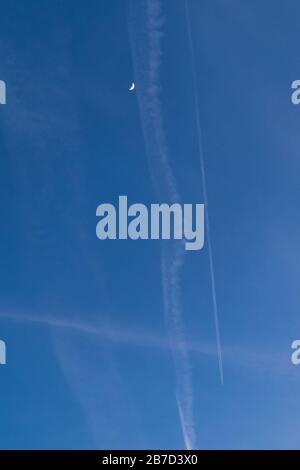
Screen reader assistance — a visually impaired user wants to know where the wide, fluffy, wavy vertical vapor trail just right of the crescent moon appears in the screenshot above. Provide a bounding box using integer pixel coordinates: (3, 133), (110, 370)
(130, 0), (196, 449)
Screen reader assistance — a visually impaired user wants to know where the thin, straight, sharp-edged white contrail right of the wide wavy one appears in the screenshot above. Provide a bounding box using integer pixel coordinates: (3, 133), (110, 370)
(185, 0), (224, 385)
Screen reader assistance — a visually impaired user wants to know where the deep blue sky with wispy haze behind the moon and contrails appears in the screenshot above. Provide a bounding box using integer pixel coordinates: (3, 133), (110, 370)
(0, 0), (300, 449)
